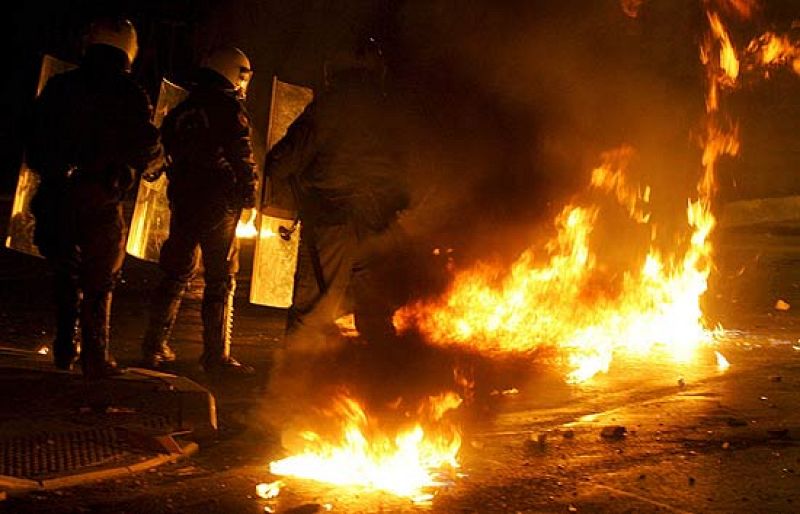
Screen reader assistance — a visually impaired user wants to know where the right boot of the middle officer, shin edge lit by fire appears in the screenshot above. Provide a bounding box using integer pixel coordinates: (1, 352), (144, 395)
(200, 279), (255, 376)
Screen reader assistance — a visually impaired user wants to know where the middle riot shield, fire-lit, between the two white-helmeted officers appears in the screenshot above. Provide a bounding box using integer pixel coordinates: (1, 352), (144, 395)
(126, 79), (187, 262)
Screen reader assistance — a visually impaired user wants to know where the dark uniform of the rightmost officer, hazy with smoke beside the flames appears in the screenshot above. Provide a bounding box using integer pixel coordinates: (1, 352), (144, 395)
(265, 69), (408, 348)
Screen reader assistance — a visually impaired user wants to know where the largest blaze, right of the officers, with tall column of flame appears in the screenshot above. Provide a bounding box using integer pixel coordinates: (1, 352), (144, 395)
(395, 10), (755, 382)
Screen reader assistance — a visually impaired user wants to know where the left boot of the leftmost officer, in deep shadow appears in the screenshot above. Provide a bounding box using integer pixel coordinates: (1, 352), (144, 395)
(53, 273), (80, 371)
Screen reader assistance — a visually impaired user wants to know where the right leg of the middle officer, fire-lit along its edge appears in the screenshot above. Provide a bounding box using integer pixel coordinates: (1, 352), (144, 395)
(200, 211), (253, 375)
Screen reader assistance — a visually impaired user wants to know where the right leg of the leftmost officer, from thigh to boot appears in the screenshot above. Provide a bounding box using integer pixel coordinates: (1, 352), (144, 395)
(78, 198), (126, 379)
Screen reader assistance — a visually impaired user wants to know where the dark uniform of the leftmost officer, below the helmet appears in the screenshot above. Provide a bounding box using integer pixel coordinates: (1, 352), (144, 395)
(26, 44), (163, 377)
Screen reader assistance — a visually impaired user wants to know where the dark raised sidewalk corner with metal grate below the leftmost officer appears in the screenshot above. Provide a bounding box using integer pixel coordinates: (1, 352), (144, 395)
(0, 348), (217, 496)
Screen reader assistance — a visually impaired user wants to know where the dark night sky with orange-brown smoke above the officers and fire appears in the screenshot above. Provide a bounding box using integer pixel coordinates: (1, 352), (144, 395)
(0, 0), (800, 260)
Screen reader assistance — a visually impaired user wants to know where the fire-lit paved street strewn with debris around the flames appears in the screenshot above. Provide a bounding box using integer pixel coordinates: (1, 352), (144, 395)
(0, 200), (800, 513)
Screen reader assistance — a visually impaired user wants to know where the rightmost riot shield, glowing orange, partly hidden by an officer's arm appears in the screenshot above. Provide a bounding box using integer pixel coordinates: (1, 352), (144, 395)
(250, 77), (314, 308)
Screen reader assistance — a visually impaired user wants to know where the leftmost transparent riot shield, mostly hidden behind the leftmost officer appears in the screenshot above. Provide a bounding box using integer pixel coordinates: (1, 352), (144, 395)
(6, 55), (75, 257)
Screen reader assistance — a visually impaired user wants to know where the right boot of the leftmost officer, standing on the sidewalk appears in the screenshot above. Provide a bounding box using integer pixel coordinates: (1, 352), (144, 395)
(80, 291), (122, 380)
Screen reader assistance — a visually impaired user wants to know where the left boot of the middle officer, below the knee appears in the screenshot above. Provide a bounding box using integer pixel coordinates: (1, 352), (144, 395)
(142, 278), (186, 368)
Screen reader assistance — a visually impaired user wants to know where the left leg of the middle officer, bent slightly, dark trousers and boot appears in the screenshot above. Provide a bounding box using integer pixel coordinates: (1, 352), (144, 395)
(142, 213), (198, 367)
